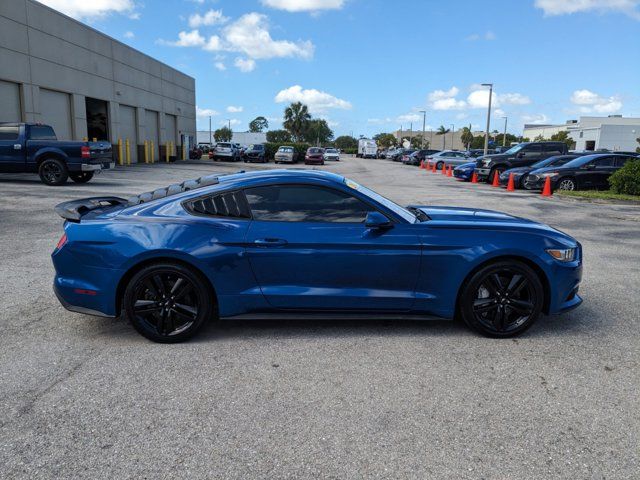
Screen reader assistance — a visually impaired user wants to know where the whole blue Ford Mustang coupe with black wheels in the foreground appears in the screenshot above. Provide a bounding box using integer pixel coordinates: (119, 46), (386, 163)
(52, 170), (582, 342)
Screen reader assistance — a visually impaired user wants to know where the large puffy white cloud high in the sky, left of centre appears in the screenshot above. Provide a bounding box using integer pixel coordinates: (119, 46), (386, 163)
(223, 12), (315, 59)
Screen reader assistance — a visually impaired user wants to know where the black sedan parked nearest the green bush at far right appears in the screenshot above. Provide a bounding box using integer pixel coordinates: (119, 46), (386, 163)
(524, 153), (638, 191)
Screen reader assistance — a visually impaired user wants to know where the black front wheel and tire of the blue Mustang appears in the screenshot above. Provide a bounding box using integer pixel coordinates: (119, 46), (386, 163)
(458, 260), (544, 338)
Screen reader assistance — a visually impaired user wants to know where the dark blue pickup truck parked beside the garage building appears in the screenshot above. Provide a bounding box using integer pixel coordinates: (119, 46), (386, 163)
(0, 123), (114, 185)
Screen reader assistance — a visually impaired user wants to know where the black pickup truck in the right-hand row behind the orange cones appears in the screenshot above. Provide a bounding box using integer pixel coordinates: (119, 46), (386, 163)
(476, 142), (569, 182)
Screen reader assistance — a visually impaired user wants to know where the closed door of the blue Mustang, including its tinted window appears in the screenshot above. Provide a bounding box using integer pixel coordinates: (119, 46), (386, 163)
(245, 184), (421, 311)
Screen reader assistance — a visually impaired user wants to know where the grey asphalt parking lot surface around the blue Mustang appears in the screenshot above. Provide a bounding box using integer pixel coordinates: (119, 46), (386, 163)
(0, 158), (640, 479)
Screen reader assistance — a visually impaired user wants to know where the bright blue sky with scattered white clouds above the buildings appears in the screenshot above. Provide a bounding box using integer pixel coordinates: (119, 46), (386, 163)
(43, 0), (640, 136)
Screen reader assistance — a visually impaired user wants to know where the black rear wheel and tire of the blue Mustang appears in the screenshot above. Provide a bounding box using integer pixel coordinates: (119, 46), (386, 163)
(123, 262), (214, 343)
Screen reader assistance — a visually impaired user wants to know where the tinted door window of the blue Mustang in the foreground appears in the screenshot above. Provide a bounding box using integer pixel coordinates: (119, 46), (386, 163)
(244, 185), (373, 223)
